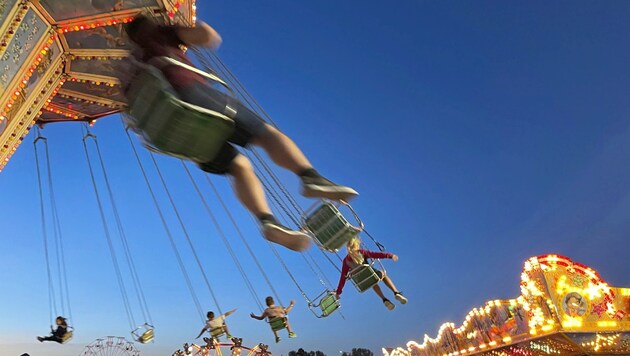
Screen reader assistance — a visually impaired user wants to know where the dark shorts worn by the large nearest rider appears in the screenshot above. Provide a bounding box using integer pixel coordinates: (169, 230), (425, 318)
(177, 84), (265, 174)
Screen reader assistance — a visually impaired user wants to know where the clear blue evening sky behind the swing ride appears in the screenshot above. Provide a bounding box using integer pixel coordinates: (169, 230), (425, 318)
(0, 0), (630, 356)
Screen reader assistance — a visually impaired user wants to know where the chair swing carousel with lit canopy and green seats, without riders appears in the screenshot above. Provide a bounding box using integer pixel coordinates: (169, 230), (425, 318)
(0, 0), (404, 343)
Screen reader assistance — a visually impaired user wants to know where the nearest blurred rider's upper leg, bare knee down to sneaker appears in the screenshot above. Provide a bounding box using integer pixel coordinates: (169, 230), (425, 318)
(251, 124), (359, 200)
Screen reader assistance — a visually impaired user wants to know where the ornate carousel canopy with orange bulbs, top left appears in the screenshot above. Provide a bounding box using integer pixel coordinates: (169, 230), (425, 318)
(0, 0), (195, 171)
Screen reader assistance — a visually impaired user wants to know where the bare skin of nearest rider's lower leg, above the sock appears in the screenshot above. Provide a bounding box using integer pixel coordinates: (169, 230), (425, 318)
(230, 154), (271, 216)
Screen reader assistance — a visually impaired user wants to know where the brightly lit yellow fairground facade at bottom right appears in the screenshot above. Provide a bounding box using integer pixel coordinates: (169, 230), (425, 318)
(383, 255), (630, 356)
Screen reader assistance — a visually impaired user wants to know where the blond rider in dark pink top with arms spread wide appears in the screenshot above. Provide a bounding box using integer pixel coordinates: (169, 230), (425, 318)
(336, 237), (407, 310)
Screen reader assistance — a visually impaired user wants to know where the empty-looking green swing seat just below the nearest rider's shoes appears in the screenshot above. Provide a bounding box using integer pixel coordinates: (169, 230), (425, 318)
(304, 202), (361, 252)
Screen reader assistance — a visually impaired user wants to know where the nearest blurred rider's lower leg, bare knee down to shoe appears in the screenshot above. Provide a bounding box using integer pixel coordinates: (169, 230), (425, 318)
(229, 154), (310, 251)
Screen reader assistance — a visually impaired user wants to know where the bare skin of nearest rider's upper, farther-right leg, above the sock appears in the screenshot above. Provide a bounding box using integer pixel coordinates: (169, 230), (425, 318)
(252, 124), (313, 174)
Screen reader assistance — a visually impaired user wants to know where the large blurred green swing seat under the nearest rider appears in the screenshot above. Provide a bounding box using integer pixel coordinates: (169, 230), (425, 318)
(127, 65), (234, 163)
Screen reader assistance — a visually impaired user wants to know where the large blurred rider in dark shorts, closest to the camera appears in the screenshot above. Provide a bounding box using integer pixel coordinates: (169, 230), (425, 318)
(125, 15), (358, 251)
